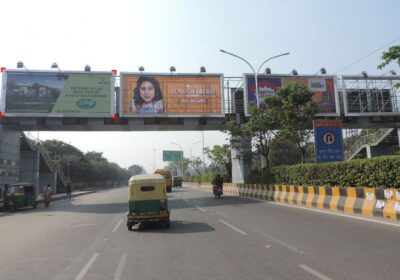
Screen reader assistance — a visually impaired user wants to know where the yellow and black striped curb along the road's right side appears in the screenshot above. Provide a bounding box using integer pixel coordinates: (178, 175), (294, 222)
(185, 183), (400, 220)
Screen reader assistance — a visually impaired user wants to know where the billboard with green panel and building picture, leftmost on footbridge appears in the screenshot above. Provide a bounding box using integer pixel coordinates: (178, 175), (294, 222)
(2, 71), (114, 117)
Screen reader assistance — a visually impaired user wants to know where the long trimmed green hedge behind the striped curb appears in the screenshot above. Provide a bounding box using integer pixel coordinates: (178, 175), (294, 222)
(272, 156), (400, 188)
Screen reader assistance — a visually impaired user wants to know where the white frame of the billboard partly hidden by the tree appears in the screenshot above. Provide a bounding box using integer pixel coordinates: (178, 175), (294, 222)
(243, 73), (340, 117)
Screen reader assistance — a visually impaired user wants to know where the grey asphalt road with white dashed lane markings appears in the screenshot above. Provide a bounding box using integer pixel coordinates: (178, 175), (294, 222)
(0, 185), (400, 280)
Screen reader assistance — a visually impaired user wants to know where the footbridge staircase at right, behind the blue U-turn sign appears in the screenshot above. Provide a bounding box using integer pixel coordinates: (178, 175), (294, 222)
(344, 128), (395, 161)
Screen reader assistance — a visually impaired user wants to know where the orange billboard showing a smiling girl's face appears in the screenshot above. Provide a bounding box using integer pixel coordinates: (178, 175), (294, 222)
(120, 73), (224, 117)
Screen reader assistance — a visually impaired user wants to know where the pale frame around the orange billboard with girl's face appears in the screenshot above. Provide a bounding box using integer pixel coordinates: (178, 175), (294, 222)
(117, 72), (225, 118)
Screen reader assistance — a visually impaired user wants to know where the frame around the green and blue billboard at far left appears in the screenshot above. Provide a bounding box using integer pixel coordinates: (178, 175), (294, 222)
(0, 69), (116, 118)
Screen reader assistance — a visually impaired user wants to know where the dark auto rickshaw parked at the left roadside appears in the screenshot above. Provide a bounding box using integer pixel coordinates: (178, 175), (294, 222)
(3, 182), (36, 211)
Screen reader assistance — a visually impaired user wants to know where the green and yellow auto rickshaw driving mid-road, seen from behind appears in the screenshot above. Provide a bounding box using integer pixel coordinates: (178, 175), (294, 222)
(127, 174), (170, 230)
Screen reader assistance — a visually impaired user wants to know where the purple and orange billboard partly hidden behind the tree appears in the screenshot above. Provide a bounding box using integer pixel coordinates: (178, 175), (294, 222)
(244, 74), (340, 116)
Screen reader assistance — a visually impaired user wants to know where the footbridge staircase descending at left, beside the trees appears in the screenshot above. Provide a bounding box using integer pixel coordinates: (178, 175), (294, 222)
(21, 132), (68, 186)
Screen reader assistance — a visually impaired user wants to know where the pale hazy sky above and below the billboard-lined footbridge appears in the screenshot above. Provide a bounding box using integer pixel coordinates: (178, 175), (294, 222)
(0, 0), (400, 171)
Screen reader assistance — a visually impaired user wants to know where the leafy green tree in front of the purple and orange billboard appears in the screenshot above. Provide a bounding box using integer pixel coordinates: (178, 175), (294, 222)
(265, 83), (318, 163)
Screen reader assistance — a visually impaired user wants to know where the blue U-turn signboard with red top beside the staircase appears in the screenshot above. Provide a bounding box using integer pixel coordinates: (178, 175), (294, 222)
(314, 120), (344, 163)
